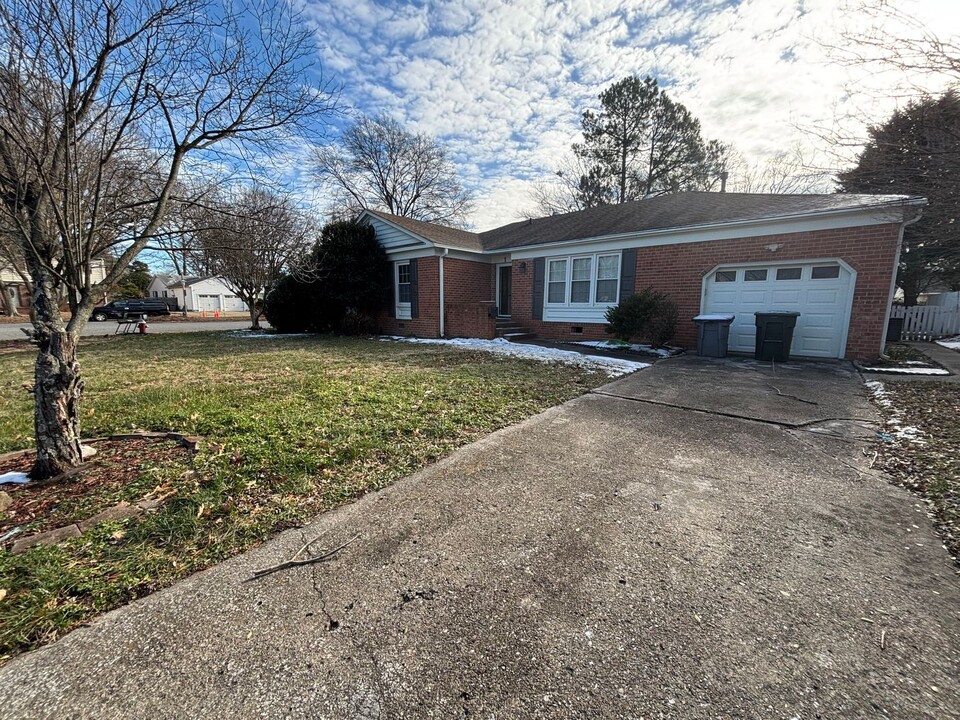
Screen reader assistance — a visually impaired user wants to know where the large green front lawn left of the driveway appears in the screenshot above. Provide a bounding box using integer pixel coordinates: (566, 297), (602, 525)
(0, 333), (606, 662)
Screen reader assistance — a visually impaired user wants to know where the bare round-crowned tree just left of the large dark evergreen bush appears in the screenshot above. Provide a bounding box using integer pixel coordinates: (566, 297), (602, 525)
(191, 187), (318, 330)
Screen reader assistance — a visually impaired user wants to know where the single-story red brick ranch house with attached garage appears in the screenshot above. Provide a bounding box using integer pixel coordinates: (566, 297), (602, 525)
(361, 192), (926, 359)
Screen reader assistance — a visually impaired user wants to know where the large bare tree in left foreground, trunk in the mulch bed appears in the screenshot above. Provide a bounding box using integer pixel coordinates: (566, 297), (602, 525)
(0, 0), (333, 479)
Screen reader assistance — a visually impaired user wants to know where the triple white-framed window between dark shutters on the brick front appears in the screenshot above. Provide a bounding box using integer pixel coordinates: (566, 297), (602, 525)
(547, 253), (620, 307)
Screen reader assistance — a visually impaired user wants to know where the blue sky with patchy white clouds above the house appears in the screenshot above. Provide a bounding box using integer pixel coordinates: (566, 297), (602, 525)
(297, 0), (960, 230)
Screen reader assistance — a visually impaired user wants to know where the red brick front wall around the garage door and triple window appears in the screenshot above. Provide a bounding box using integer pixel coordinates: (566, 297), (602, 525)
(513, 224), (900, 358)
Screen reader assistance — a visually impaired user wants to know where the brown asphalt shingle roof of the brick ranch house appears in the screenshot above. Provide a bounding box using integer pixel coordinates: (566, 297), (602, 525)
(371, 192), (920, 252)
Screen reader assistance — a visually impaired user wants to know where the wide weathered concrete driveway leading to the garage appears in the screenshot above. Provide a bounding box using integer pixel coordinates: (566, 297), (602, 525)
(0, 357), (960, 719)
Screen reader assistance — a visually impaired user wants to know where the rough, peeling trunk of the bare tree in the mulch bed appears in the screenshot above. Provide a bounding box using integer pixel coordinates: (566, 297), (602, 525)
(30, 281), (83, 480)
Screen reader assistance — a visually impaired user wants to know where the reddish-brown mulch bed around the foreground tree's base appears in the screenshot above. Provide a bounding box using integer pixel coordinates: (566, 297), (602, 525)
(0, 438), (193, 536)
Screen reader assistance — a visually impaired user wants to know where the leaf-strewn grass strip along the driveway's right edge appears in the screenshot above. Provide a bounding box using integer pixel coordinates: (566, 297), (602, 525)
(880, 380), (960, 561)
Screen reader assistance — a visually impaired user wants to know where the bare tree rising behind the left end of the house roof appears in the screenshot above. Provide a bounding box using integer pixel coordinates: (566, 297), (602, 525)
(315, 116), (472, 226)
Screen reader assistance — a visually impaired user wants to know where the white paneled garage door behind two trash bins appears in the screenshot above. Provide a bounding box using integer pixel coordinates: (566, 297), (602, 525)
(702, 262), (854, 358)
